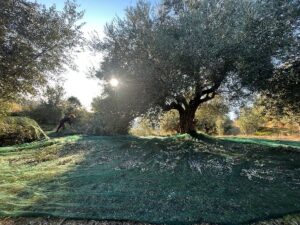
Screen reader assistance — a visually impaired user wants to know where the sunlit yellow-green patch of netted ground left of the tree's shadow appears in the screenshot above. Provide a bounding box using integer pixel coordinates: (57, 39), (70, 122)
(0, 136), (84, 215)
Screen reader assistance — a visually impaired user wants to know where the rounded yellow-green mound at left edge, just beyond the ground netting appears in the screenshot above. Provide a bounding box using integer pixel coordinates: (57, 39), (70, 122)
(0, 117), (48, 146)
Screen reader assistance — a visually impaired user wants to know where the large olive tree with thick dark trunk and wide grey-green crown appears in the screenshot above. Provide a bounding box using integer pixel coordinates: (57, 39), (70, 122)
(93, 0), (300, 133)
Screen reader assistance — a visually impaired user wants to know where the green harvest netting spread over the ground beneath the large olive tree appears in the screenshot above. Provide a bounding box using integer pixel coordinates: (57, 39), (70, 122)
(0, 136), (300, 224)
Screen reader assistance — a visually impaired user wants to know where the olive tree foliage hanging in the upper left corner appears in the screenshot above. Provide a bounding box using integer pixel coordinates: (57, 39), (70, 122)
(0, 0), (83, 101)
